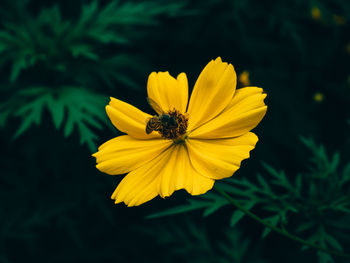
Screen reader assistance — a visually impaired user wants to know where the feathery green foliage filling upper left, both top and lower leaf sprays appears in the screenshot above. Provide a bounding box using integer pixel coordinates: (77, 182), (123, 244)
(0, 0), (184, 151)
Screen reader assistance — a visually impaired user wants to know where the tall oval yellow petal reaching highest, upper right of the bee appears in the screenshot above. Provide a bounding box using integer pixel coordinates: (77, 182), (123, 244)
(187, 57), (237, 130)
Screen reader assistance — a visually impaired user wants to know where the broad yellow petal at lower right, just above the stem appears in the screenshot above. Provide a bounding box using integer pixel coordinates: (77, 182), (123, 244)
(186, 132), (258, 180)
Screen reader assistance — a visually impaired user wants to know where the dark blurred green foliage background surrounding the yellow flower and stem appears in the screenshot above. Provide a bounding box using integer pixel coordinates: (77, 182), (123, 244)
(0, 0), (350, 263)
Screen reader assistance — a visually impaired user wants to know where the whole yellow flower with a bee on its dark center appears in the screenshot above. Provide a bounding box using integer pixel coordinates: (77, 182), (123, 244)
(93, 57), (267, 206)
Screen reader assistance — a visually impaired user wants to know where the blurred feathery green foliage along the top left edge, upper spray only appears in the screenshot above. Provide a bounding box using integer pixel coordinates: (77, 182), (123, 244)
(0, 1), (184, 84)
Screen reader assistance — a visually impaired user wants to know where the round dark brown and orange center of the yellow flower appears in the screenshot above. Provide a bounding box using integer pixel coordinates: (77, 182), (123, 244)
(155, 109), (188, 143)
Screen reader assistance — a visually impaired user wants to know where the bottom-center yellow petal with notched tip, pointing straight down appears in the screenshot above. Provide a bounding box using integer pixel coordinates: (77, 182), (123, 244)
(159, 144), (214, 198)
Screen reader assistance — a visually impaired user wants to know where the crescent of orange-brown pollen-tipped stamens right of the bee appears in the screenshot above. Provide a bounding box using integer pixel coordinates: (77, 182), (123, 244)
(159, 109), (188, 140)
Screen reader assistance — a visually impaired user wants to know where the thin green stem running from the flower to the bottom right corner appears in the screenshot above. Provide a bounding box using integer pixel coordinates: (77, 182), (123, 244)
(214, 185), (350, 259)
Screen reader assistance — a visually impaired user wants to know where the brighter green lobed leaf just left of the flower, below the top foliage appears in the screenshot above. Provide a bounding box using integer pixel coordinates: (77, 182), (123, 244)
(9, 86), (108, 151)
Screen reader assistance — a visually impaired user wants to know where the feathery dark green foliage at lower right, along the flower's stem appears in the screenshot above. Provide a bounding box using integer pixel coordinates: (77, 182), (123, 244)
(149, 138), (350, 263)
